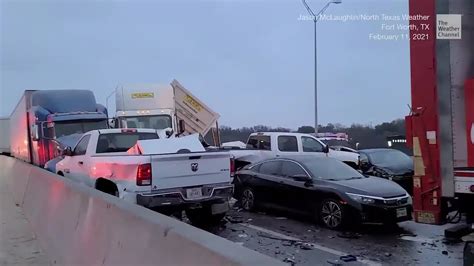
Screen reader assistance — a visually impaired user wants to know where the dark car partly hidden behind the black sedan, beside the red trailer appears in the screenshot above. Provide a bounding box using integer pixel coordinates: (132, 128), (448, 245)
(359, 149), (414, 195)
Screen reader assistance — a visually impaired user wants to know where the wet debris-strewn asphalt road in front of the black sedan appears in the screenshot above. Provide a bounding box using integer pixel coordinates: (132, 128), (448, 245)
(194, 209), (464, 265)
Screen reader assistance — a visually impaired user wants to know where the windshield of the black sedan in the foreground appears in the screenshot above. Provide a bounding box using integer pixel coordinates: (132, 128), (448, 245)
(302, 158), (364, 181)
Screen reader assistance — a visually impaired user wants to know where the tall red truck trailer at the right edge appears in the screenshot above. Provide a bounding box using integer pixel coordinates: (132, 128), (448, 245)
(406, 0), (474, 224)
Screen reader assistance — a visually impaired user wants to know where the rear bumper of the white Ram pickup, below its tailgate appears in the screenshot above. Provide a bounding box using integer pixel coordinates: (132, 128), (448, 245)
(137, 183), (234, 209)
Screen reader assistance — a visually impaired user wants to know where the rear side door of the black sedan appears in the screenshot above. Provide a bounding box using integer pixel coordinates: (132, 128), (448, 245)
(252, 160), (281, 204)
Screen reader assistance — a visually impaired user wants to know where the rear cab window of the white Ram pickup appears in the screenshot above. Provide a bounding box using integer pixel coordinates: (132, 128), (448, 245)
(96, 132), (159, 153)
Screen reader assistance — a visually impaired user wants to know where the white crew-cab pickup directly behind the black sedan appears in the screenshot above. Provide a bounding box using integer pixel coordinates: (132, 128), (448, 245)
(227, 132), (360, 169)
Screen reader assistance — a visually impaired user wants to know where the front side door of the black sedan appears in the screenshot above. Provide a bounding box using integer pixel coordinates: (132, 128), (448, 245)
(278, 160), (312, 212)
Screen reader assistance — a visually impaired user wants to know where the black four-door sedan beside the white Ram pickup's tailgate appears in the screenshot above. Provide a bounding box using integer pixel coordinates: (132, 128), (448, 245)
(234, 156), (412, 229)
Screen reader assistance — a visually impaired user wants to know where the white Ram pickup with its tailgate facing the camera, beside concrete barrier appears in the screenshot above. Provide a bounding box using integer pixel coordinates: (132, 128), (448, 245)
(56, 129), (233, 224)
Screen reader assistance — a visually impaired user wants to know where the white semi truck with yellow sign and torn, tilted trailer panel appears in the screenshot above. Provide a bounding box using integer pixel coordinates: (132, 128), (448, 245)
(113, 80), (219, 140)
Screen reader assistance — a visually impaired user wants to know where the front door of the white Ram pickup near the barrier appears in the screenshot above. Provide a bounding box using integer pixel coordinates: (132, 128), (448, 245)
(64, 135), (91, 183)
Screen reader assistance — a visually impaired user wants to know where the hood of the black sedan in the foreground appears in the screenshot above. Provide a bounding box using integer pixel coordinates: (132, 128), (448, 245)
(330, 176), (407, 198)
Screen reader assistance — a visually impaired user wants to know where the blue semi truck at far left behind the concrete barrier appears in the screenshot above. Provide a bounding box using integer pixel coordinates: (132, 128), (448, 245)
(10, 90), (108, 167)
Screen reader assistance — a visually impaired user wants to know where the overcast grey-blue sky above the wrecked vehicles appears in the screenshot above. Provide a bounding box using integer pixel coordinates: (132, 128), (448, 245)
(0, 0), (410, 128)
